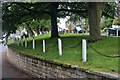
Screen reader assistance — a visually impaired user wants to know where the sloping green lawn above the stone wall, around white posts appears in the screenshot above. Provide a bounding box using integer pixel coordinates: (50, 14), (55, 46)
(9, 34), (120, 73)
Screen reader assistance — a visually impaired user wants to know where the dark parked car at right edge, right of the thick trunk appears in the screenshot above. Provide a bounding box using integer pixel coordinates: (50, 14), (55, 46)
(108, 25), (120, 36)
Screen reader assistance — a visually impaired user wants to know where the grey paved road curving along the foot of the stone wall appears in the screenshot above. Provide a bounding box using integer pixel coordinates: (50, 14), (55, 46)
(0, 44), (29, 79)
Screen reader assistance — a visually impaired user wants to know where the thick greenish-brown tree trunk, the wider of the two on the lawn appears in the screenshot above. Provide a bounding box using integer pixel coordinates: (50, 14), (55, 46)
(88, 2), (104, 42)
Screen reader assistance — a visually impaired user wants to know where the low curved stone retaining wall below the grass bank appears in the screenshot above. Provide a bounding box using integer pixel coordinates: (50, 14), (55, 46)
(7, 49), (116, 80)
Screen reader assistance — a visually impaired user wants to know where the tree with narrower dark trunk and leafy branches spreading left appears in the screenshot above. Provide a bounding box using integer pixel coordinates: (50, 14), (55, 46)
(1, 3), (87, 37)
